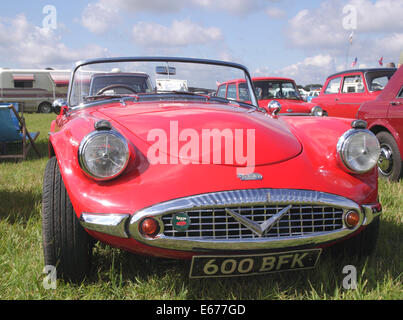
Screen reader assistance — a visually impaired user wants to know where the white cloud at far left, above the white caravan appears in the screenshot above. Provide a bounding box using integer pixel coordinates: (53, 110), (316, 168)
(0, 15), (106, 68)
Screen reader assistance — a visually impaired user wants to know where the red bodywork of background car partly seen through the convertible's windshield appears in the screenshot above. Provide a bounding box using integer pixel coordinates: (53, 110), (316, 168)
(217, 77), (317, 114)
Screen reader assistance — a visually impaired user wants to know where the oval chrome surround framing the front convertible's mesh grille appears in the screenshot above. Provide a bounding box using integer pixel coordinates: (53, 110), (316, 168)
(129, 189), (369, 251)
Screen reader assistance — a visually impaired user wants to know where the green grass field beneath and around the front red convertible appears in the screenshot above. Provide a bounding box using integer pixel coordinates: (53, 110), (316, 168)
(0, 114), (403, 300)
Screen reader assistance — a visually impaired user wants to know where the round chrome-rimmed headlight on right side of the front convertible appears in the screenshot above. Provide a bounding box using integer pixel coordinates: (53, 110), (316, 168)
(337, 129), (380, 173)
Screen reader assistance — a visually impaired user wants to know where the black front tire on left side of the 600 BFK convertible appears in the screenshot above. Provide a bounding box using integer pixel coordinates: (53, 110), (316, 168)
(42, 157), (92, 282)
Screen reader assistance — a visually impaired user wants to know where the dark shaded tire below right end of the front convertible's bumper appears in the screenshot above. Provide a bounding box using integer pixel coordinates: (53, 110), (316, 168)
(331, 217), (380, 258)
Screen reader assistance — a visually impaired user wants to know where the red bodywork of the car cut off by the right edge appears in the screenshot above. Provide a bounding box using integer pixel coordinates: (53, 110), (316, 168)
(357, 67), (403, 160)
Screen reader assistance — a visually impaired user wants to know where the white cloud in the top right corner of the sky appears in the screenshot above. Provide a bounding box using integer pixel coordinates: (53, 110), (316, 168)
(286, 0), (403, 50)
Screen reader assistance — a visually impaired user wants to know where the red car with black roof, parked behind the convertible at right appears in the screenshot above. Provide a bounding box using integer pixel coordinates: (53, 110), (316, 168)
(312, 68), (396, 118)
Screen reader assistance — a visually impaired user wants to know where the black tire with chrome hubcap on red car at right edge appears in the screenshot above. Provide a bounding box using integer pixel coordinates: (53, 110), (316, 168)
(376, 131), (402, 181)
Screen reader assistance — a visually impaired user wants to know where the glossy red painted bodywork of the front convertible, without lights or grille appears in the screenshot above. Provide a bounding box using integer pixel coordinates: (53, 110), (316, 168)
(49, 102), (378, 259)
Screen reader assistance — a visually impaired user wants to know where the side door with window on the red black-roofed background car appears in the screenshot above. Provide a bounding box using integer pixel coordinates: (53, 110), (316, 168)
(335, 73), (368, 118)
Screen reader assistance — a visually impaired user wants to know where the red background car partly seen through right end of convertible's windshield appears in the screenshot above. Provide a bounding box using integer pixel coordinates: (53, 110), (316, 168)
(216, 77), (326, 116)
